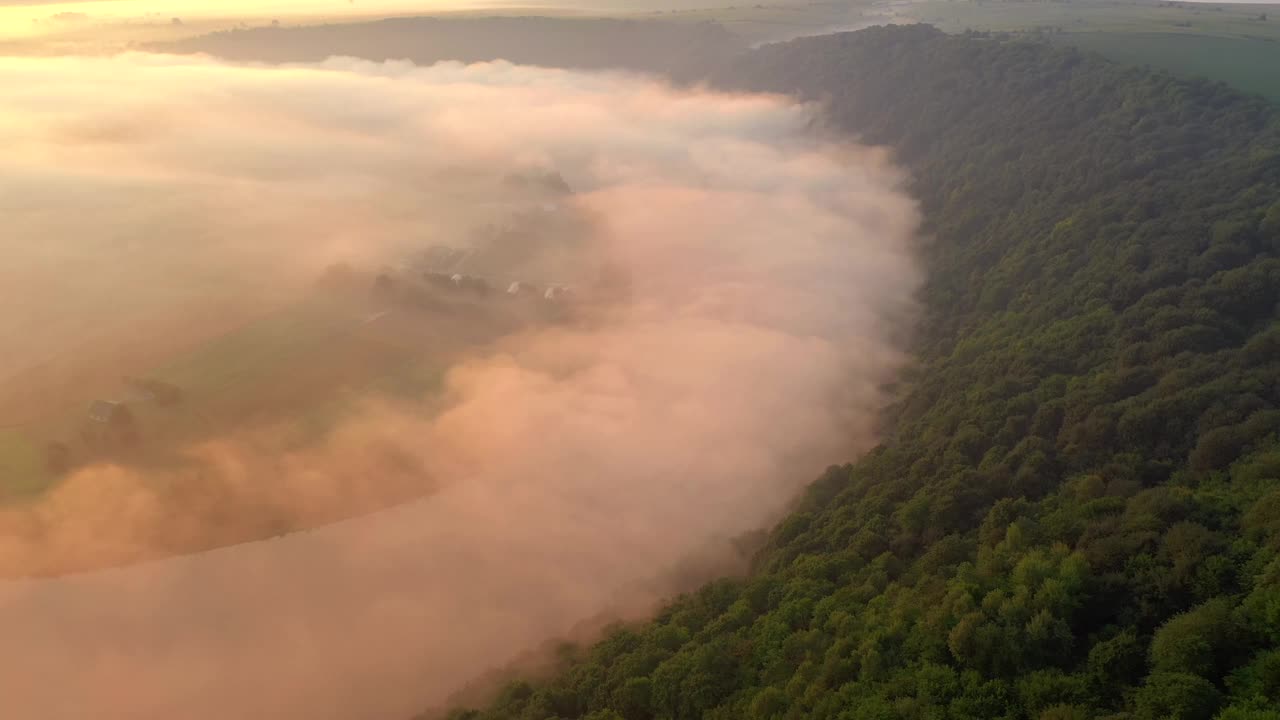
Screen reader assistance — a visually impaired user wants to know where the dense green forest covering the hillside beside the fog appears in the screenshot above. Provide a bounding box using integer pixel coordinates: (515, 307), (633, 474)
(437, 27), (1280, 720)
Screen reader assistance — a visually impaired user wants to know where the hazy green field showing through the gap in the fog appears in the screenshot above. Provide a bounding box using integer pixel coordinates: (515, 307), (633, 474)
(0, 280), (522, 500)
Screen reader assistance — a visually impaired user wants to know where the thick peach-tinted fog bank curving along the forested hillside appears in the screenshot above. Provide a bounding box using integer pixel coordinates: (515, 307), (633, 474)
(0, 55), (922, 720)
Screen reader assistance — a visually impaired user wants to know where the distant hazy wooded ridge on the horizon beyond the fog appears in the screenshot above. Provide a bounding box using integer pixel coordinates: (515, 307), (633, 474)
(151, 17), (745, 78)
